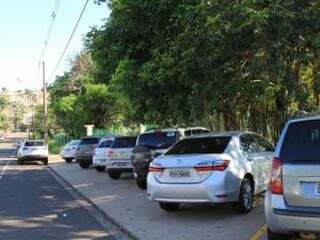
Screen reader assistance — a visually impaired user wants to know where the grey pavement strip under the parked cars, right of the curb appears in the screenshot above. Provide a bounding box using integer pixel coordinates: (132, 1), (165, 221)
(49, 156), (264, 240)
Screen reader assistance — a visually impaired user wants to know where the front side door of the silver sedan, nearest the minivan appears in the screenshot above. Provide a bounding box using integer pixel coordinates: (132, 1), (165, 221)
(254, 135), (274, 191)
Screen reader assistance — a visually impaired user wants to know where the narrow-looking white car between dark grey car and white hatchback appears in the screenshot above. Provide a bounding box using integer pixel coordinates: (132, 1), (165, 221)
(93, 137), (114, 172)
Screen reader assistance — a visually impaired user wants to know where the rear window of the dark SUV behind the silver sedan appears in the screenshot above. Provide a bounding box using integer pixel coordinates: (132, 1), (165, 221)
(138, 131), (179, 149)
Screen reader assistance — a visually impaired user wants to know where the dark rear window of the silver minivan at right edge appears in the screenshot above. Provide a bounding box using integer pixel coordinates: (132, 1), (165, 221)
(280, 120), (320, 162)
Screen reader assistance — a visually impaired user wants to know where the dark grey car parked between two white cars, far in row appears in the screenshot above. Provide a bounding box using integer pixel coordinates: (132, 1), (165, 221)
(75, 136), (100, 168)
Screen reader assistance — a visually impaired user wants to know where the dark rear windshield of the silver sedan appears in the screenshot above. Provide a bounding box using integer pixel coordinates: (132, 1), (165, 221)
(165, 137), (231, 155)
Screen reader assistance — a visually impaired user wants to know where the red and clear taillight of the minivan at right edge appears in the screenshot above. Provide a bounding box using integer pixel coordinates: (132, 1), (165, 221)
(269, 158), (283, 195)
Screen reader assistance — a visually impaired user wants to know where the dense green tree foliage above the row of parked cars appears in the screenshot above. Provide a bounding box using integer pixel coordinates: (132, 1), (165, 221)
(51, 0), (320, 141)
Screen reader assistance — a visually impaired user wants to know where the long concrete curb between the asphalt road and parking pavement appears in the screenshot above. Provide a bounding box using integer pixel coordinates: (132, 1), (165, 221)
(48, 165), (139, 240)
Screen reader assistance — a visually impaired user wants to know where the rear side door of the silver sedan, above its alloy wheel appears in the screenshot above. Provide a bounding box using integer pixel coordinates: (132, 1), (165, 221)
(240, 133), (264, 192)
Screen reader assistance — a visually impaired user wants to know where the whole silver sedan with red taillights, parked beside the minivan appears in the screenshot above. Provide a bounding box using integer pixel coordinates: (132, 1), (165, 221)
(147, 132), (274, 213)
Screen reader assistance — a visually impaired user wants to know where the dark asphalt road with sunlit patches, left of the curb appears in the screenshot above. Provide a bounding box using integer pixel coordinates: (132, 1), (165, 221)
(0, 140), (114, 240)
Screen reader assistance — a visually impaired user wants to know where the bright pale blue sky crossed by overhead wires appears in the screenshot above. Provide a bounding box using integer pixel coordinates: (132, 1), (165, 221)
(0, 0), (110, 90)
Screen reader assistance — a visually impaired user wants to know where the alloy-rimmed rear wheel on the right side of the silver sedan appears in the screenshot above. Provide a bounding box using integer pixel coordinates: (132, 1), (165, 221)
(235, 178), (254, 214)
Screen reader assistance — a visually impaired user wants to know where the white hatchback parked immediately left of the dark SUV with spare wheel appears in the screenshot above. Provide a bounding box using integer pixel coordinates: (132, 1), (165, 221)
(106, 137), (137, 179)
